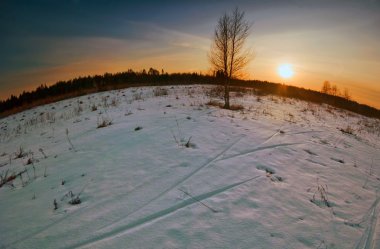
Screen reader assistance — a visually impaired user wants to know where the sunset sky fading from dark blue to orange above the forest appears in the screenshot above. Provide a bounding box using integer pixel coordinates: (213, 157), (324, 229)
(0, 0), (380, 108)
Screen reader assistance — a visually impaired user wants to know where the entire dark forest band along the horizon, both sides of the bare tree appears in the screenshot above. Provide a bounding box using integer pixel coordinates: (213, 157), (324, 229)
(0, 68), (380, 119)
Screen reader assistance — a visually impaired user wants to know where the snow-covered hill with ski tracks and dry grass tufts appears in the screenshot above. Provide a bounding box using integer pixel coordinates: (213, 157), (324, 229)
(0, 86), (380, 249)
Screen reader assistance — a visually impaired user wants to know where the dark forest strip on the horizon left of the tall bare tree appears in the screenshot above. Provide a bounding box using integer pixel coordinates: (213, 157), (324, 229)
(0, 68), (215, 117)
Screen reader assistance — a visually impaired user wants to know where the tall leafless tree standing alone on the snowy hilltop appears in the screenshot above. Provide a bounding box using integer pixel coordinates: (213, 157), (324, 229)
(209, 8), (252, 109)
